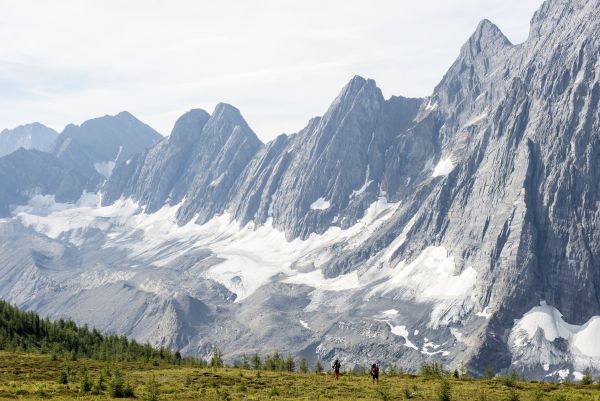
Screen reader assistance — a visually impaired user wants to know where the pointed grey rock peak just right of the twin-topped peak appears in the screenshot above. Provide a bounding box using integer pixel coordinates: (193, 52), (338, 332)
(230, 77), (422, 238)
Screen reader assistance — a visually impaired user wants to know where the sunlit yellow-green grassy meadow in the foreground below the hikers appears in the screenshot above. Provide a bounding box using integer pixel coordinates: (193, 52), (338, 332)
(0, 351), (600, 401)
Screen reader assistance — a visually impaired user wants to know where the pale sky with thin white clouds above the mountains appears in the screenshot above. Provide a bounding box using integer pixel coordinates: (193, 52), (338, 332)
(0, 0), (542, 141)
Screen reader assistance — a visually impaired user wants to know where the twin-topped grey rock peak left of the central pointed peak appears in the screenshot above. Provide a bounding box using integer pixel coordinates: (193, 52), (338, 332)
(103, 103), (262, 223)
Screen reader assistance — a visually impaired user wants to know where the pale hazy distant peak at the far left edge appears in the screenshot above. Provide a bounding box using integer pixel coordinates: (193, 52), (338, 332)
(0, 123), (58, 157)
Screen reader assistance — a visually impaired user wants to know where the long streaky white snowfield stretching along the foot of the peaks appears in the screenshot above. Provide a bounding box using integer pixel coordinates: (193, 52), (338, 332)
(15, 194), (477, 327)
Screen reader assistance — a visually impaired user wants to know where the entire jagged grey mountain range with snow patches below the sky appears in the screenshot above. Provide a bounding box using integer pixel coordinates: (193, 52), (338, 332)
(0, 0), (600, 380)
